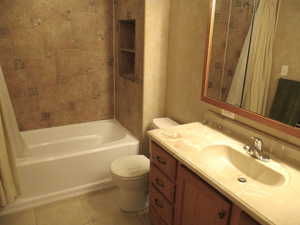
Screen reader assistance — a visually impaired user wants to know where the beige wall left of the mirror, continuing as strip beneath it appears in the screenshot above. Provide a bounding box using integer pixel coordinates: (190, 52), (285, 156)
(166, 0), (299, 145)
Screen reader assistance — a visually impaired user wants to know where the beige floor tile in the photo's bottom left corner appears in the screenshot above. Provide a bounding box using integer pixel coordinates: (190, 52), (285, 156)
(0, 210), (37, 225)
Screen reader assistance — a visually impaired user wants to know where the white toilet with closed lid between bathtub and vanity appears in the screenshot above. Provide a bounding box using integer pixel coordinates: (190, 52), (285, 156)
(110, 118), (178, 212)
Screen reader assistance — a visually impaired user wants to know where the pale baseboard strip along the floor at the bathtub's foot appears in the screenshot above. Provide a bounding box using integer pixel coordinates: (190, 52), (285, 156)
(0, 178), (115, 216)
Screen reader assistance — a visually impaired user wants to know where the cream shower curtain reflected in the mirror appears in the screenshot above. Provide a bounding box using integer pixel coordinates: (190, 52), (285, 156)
(227, 0), (280, 115)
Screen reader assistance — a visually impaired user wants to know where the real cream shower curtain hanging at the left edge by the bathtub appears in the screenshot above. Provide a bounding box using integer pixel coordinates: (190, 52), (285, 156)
(0, 67), (25, 207)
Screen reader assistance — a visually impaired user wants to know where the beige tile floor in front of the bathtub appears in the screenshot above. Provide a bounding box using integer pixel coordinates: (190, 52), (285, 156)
(0, 188), (150, 225)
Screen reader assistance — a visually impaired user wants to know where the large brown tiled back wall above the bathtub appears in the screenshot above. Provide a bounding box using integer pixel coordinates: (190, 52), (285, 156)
(0, 0), (114, 130)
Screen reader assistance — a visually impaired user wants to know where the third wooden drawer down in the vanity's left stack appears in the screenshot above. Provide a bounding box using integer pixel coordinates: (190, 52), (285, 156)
(150, 185), (173, 225)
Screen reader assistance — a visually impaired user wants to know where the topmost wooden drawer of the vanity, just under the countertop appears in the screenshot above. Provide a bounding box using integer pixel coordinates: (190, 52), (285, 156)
(151, 142), (177, 181)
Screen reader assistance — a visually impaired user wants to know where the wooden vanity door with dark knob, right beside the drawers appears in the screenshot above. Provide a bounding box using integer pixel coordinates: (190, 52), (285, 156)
(175, 166), (231, 225)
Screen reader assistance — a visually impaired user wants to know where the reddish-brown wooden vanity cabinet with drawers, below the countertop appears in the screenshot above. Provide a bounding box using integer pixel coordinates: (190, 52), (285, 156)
(149, 141), (259, 225)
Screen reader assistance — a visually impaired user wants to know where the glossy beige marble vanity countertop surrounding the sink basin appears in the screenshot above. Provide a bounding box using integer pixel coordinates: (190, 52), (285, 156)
(148, 123), (300, 225)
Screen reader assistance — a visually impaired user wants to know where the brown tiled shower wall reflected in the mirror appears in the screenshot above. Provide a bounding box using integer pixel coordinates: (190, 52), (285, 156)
(208, 0), (255, 101)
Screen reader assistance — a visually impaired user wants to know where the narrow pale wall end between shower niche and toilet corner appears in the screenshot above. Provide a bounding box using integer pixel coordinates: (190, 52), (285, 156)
(143, 0), (171, 154)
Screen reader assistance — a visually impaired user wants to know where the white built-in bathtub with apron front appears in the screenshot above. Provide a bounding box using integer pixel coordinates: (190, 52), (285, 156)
(2, 120), (139, 214)
